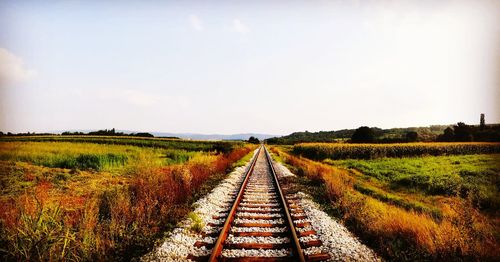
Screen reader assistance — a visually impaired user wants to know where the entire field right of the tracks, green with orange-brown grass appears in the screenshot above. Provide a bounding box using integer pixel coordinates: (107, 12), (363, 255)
(272, 143), (500, 260)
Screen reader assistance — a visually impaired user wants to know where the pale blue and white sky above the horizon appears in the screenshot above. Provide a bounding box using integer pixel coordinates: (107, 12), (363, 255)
(0, 0), (500, 135)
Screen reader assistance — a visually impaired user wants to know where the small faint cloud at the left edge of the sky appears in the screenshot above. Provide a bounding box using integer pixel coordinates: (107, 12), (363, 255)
(0, 48), (37, 85)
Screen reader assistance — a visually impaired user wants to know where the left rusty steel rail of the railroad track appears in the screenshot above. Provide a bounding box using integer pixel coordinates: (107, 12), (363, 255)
(208, 145), (264, 262)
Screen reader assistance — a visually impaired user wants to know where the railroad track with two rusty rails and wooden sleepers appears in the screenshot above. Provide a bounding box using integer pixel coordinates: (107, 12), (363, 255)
(188, 146), (330, 261)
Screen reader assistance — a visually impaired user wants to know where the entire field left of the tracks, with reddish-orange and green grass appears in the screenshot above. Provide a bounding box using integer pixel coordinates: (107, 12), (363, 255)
(0, 137), (255, 260)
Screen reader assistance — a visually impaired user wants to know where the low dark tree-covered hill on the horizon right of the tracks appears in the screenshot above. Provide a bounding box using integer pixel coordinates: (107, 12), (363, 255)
(266, 125), (451, 144)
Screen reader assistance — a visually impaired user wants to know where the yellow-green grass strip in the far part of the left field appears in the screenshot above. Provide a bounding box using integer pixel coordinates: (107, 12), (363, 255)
(0, 142), (204, 171)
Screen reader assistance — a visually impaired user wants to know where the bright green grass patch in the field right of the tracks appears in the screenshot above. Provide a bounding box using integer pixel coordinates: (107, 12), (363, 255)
(324, 154), (500, 210)
